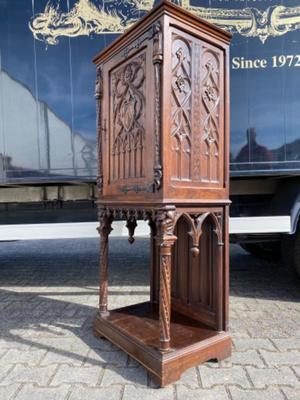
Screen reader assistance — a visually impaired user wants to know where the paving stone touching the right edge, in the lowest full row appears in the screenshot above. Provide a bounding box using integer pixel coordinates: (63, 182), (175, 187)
(246, 367), (300, 388)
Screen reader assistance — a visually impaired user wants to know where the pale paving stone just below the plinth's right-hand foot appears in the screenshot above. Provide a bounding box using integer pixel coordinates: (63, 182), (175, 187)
(199, 365), (251, 388)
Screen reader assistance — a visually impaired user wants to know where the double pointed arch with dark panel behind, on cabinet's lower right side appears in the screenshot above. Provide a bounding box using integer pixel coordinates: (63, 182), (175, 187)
(171, 207), (225, 329)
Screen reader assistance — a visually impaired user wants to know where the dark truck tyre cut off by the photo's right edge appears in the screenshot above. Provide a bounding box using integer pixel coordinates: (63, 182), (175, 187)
(282, 231), (300, 278)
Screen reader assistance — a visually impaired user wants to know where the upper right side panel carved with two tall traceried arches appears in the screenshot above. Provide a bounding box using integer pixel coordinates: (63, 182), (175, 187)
(170, 28), (225, 188)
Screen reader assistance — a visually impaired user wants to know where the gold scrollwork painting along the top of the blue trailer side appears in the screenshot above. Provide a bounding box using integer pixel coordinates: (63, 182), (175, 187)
(29, 0), (300, 45)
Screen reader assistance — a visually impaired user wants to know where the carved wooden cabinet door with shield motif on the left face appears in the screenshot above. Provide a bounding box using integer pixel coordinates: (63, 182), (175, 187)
(103, 38), (154, 196)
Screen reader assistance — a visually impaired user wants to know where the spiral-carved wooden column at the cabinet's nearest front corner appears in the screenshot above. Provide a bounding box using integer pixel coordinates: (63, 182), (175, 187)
(156, 211), (177, 351)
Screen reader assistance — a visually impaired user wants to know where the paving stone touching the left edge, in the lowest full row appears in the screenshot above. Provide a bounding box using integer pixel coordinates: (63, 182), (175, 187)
(1, 364), (56, 386)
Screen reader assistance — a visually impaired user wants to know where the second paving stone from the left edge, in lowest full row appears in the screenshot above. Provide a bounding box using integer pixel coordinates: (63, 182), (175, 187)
(51, 365), (102, 386)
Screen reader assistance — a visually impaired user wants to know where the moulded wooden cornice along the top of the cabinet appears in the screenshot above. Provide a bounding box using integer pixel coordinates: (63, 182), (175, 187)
(93, 0), (232, 64)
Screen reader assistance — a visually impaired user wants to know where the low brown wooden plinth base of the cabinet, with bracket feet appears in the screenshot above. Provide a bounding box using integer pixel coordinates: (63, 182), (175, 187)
(94, 302), (231, 387)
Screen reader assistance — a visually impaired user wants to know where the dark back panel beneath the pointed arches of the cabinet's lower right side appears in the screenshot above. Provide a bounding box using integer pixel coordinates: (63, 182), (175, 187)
(172, 217), (218, 327)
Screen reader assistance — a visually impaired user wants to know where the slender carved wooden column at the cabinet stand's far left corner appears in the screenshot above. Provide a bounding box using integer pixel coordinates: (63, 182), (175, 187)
(97, 209), (113, 314)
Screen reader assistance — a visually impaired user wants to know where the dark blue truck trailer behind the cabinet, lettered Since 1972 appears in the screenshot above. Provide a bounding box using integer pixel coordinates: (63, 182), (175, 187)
(0, 0), (300, 274)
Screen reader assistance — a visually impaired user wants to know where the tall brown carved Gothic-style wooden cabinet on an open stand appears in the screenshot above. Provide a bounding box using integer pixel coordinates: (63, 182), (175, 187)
(94, 1), (231, 386)
